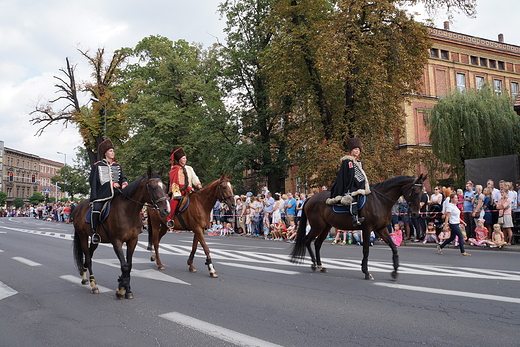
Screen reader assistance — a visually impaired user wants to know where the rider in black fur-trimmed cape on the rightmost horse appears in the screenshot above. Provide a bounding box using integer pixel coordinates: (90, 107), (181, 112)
(326, 137), (370, 225)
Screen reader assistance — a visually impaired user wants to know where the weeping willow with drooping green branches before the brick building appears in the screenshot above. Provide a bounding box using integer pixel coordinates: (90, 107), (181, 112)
(426, 85), (520, 186)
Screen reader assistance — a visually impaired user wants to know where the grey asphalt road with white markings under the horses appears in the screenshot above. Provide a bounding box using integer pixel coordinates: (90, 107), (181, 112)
(0, 218), (520, 346)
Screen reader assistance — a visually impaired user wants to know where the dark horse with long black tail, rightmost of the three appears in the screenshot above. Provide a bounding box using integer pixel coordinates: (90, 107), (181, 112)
(291, 174), (427, 279)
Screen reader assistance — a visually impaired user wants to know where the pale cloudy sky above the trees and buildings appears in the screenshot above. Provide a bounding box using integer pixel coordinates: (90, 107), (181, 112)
(0, 0), (520, 165)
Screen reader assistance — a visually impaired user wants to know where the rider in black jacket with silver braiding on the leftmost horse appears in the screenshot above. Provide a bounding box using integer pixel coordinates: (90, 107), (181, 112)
(89, 139), (128, 243)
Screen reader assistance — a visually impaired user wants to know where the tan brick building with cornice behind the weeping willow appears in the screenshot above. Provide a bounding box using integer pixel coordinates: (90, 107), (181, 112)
(400, 22), (520, 182)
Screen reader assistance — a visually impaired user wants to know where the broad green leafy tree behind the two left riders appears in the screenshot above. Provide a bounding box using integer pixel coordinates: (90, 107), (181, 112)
(120, 36), (241, 183)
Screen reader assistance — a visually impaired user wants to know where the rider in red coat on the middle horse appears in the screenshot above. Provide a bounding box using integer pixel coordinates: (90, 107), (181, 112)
(166, 147), (202, 228)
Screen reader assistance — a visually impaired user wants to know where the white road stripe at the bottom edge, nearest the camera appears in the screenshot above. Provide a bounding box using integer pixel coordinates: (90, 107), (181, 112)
(159, 312), (280, 347)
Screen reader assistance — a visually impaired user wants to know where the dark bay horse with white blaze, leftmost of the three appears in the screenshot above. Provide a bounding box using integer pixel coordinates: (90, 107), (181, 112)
(72, 168), (170, 299)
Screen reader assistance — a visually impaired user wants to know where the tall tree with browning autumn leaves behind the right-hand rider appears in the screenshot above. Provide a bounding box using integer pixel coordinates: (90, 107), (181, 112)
(262, 0), (429, 185)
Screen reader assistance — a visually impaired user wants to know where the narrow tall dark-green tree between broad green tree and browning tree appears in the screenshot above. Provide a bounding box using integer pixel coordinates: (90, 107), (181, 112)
(219, 0), (289, 191)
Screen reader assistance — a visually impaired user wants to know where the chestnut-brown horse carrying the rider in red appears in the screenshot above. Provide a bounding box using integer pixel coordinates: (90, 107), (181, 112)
(148, 175), (235, 278)
